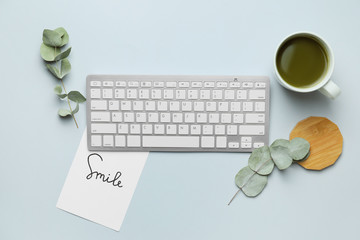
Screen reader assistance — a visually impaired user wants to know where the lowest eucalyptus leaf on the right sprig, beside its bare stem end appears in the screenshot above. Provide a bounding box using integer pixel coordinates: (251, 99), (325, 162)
(235, 166), (267, 197)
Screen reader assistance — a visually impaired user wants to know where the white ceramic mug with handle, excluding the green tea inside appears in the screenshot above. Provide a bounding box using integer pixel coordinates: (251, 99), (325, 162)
(274, 32), (341, 99)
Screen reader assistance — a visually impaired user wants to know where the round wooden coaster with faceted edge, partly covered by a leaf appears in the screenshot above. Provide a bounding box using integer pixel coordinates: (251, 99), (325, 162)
(290, 117), (343, 170)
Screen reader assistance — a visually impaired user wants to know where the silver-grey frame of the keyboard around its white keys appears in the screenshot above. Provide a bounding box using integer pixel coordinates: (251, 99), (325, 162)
(86, 75), (270, 152)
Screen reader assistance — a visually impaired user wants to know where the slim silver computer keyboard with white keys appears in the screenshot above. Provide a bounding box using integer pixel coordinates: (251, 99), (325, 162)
(86, 75), (270, 152)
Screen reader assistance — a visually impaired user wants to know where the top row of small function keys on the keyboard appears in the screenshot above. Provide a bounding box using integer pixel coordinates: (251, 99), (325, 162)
(90, 81), (266, 88)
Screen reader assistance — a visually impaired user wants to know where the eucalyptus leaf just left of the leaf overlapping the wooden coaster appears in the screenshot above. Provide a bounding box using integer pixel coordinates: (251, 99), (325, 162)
(270, 139), (292, 170)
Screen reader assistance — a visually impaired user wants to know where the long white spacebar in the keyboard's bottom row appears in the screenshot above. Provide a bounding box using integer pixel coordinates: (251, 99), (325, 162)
(143, 136), (200, 148)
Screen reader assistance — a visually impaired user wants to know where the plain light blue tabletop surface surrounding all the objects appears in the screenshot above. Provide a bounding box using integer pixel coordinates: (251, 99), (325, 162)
(0, 0), (360, 240)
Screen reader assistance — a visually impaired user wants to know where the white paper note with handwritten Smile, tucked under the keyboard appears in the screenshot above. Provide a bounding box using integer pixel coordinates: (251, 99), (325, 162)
(56, 129), (148, 231)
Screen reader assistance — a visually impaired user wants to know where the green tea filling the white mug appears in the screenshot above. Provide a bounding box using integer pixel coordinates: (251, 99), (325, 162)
(276, 36), (328, 88)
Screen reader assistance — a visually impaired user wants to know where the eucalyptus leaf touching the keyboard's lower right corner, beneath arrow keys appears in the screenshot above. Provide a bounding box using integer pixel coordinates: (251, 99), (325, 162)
(249, 146), (274, 175)
